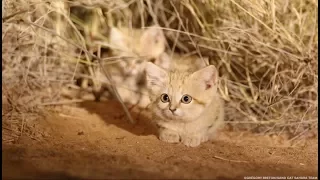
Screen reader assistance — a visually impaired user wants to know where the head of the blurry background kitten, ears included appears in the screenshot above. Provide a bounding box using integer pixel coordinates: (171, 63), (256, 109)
(110, 26), (165, 75)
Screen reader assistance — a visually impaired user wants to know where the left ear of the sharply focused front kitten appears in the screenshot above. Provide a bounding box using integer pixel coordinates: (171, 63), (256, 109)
(145, 62), (167, 89)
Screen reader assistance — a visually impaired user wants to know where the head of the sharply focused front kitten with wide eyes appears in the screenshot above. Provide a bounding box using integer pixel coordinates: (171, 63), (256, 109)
(146, 62), (218, 121)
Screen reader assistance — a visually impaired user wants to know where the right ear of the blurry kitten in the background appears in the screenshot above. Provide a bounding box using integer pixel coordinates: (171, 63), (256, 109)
(140, 25), (166, 57)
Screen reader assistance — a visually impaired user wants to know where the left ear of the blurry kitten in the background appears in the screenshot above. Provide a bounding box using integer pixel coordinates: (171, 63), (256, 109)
(109, 27), (128, 50)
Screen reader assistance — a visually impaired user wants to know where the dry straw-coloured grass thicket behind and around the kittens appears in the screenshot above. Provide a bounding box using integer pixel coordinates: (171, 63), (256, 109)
(2, 0), (318, 143)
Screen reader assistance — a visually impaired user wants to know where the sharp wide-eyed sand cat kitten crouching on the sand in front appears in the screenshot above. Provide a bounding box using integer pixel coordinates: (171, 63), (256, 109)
(146, 62), (224, 147)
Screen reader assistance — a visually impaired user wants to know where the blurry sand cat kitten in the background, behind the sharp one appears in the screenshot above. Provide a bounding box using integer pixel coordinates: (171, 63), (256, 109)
(97, 26), (166, 106)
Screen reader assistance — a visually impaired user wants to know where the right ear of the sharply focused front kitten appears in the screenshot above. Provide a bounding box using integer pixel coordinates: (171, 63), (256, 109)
(191, 65), (219, 90)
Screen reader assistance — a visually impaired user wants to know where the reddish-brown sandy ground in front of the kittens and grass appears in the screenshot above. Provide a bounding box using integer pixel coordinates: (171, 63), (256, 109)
(2, 102), (318, 180)
